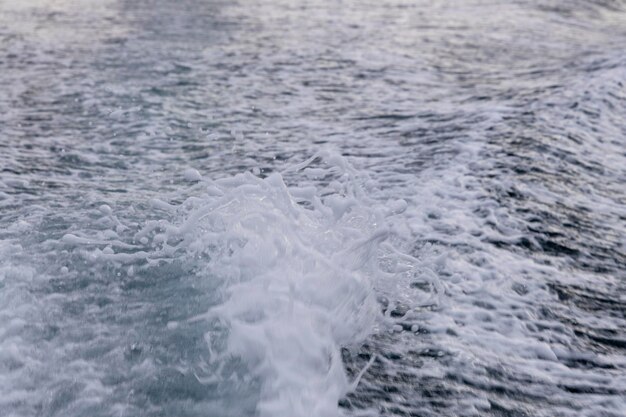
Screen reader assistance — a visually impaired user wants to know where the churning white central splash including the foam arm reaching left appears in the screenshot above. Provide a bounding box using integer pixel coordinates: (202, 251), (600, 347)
(39, 152), (412, 417)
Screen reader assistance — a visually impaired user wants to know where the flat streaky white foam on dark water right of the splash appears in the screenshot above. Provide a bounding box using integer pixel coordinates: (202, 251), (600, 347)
(356, 135), (626, 416)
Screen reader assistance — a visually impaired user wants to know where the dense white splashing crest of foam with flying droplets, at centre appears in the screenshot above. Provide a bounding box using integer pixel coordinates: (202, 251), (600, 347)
(119, 152), (408, 417)
